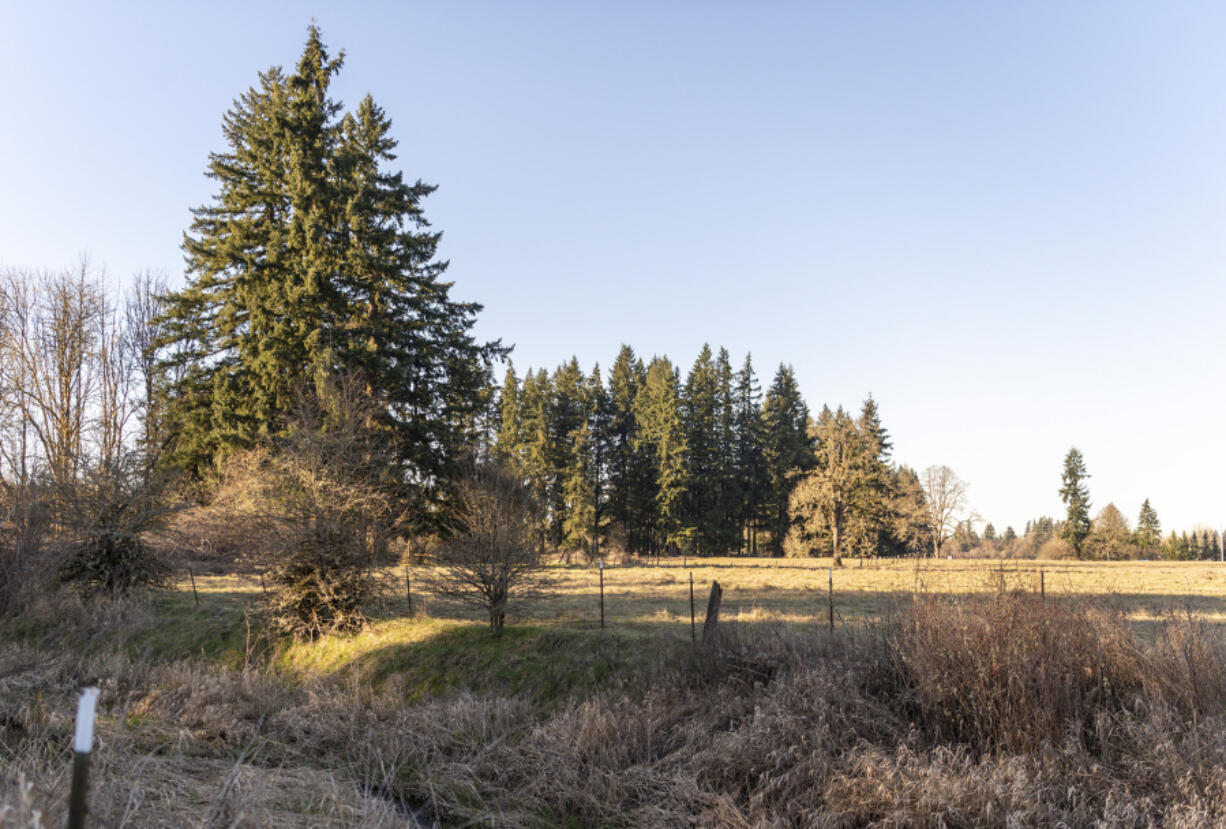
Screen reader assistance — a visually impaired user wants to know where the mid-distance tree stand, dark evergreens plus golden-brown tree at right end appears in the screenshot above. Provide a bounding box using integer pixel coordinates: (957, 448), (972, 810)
(493, 345), (932, 564)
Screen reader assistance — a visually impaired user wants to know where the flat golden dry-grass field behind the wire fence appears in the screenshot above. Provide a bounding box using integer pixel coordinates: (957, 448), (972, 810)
(178, 558), (1226, 628)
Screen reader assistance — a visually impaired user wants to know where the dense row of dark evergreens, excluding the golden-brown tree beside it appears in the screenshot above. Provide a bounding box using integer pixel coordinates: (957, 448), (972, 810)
(493, 346), (813, 556)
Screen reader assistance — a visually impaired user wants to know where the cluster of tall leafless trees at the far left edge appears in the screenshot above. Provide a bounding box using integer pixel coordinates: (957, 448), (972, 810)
(0, 261), (175, 608)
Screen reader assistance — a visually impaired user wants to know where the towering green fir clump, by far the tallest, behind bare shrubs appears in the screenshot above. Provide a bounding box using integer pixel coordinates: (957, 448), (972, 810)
(158, 27), (505, 507)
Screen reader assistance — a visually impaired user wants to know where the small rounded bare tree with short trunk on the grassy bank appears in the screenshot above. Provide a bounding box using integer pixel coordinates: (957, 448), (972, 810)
(423, 461), (549, 634)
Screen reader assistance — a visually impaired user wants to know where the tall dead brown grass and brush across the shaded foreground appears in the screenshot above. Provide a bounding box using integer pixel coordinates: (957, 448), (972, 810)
(7, 594), (1226, 828)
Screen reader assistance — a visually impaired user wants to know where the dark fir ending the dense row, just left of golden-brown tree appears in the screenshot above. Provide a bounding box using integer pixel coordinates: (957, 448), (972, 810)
(763, 365), (814, 556)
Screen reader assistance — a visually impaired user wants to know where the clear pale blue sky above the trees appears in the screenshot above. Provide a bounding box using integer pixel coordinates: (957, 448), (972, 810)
(0, 0), (1226, 530)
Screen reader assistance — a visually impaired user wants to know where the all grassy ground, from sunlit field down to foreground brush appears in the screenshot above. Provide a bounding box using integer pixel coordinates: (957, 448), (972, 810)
(7, 559), (1226, 827)
